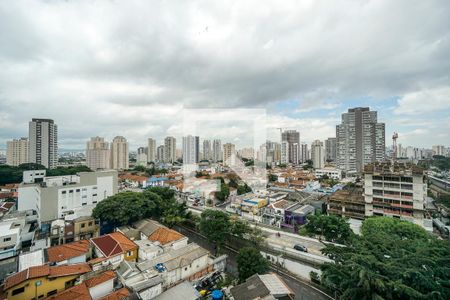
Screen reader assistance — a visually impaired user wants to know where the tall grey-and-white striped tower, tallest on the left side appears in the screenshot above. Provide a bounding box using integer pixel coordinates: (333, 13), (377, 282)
(28, 119), (58, 169)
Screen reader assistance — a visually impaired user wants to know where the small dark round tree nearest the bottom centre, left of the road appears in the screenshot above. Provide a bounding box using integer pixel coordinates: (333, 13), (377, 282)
(236, 247), (269, 282)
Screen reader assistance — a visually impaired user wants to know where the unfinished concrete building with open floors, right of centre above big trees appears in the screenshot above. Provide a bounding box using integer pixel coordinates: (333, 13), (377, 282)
(364, 162), (427, 226)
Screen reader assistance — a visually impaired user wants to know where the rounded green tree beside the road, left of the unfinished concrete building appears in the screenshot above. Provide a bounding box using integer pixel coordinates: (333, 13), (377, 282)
(302, 215), (353, 244)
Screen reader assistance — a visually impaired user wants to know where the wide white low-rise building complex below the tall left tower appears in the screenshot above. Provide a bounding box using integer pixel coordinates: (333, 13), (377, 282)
(18, 170), (117, 225)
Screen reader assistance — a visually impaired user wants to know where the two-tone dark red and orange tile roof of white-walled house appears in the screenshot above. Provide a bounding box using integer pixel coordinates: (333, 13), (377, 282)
(91, 232), (138, 257)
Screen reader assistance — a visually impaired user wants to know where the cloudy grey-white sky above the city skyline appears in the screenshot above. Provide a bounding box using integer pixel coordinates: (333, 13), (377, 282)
(0, 0), (450, 150)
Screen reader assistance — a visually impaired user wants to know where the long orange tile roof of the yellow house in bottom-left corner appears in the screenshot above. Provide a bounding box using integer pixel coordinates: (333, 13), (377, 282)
(4, 263), (91, 290)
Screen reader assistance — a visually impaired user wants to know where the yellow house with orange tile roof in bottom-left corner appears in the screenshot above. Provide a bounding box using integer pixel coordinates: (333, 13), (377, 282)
(3, 263), (91, 300)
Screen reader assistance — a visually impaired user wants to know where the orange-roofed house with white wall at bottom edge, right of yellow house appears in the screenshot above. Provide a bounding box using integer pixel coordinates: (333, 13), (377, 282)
(50, 270), (129, 300)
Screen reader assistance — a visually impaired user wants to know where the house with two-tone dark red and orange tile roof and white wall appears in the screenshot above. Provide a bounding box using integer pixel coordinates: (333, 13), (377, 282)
(89, 231), (138, 270)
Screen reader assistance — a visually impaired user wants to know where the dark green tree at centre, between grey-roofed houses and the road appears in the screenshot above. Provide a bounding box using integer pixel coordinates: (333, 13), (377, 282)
(199, 209), (231, 252)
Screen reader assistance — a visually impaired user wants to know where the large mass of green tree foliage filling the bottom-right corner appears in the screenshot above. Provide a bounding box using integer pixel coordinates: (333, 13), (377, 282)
(321, 217), (450, 299)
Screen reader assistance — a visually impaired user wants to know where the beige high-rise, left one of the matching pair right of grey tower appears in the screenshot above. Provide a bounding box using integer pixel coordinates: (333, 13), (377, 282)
(86, 136), (111, 171)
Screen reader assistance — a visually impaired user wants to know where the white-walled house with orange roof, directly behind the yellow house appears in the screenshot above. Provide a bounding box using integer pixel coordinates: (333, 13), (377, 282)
(45, 240), (91, 265)
